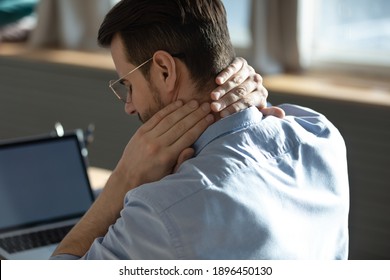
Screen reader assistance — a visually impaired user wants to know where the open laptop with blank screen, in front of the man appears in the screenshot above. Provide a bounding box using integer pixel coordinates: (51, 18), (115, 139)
(0, 134), (94, 260)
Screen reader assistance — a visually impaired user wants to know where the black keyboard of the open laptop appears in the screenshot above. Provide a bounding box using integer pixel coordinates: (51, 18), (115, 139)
(0, 225), (73, 253)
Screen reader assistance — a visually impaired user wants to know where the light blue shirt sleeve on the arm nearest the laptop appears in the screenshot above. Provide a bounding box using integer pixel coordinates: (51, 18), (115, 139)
(71, 192), (178, 260)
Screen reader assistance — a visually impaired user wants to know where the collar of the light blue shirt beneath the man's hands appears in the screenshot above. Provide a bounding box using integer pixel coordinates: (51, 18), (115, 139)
(193, 106), (263, 155)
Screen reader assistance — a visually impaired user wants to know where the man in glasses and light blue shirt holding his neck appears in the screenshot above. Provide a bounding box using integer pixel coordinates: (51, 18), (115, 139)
(53, 0), (349, 259)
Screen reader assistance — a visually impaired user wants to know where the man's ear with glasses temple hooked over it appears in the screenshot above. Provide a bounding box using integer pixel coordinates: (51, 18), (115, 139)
(151, 50), (177, 97)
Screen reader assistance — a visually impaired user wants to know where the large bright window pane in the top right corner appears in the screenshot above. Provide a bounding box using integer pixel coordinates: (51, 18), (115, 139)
(299, 0), (390, 73)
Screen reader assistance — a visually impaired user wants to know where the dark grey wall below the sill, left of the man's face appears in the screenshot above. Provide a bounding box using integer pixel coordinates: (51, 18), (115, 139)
(0, 56), (139, 169)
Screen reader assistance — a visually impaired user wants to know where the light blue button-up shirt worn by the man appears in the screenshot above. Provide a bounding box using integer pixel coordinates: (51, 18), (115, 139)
(52, 105), (349, 259)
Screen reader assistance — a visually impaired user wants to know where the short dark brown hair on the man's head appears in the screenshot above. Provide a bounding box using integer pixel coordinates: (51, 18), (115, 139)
(98, 0), (235, 89)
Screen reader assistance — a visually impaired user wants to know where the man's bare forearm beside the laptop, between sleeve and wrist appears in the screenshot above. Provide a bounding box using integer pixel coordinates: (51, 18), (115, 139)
(53, 171), (136, 257)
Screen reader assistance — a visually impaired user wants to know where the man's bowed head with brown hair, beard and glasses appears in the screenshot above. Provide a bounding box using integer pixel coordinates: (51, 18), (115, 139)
(98, 0), (235, 121)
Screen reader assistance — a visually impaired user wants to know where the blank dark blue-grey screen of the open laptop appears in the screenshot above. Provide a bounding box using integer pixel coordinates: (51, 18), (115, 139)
(0, 135), (93, 232)
